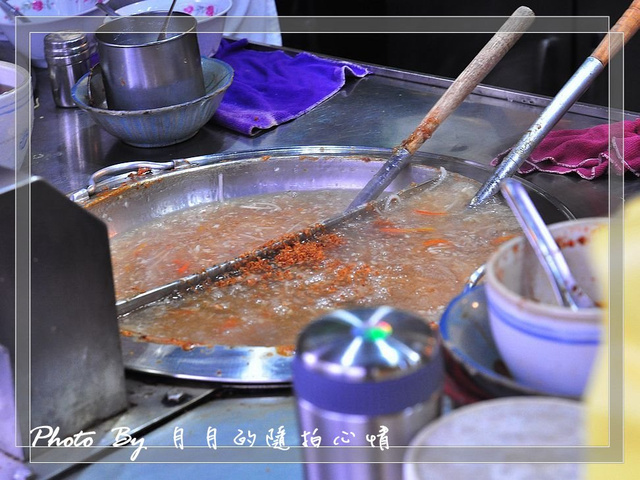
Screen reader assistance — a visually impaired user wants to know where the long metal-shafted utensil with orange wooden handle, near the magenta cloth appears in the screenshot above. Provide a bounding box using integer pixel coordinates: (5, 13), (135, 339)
(469, 0), (640, 207)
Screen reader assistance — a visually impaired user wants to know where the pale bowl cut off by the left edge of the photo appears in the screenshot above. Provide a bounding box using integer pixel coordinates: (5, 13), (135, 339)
(0, 62), (33, 169)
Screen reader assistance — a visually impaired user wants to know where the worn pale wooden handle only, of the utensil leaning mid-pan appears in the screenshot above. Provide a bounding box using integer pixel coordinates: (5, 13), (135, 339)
(402, 6), (536, 154)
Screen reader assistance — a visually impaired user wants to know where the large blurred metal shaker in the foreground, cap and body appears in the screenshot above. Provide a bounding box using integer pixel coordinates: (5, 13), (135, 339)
(292, 307), (444, 480)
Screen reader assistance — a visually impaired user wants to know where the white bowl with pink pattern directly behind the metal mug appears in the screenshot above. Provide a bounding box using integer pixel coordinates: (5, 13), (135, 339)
(116, 0), (233, 57)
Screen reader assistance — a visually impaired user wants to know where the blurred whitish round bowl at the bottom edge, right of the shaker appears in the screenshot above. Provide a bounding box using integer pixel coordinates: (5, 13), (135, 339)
(402, 397), (585, 480)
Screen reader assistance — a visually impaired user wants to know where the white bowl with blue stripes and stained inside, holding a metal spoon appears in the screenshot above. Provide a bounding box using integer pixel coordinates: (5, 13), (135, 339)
(486, 218), (608, 397)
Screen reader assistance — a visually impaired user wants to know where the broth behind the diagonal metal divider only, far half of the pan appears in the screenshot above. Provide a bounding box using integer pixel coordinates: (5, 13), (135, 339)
(111, 191), (352, 298)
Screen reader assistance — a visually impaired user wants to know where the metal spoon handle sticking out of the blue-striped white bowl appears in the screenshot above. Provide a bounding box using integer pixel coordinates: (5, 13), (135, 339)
(500, 178), (595, 310)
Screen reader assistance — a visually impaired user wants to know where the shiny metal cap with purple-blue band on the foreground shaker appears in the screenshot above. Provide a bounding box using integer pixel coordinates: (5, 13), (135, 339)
(293, 307), (444, 414)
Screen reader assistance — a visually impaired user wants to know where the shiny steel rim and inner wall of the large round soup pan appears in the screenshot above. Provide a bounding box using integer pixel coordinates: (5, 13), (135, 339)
(71, 146), (573, 384)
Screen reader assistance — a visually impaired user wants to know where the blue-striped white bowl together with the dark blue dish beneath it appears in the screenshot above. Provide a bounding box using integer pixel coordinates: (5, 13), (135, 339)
(440, 218), (608, 398)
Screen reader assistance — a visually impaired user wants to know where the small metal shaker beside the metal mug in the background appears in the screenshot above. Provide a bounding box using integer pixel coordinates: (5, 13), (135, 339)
(44, 32), (91, 107)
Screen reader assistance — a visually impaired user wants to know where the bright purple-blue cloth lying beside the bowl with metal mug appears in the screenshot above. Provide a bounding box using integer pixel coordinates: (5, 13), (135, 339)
(213, 38), (370, 135)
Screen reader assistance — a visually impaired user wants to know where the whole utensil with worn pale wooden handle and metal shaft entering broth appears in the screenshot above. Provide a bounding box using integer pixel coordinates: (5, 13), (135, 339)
(346, 5), (536, 211)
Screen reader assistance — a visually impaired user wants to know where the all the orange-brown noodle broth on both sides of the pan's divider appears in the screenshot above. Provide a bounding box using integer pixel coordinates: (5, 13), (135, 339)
(111, 173), (520, 349)
